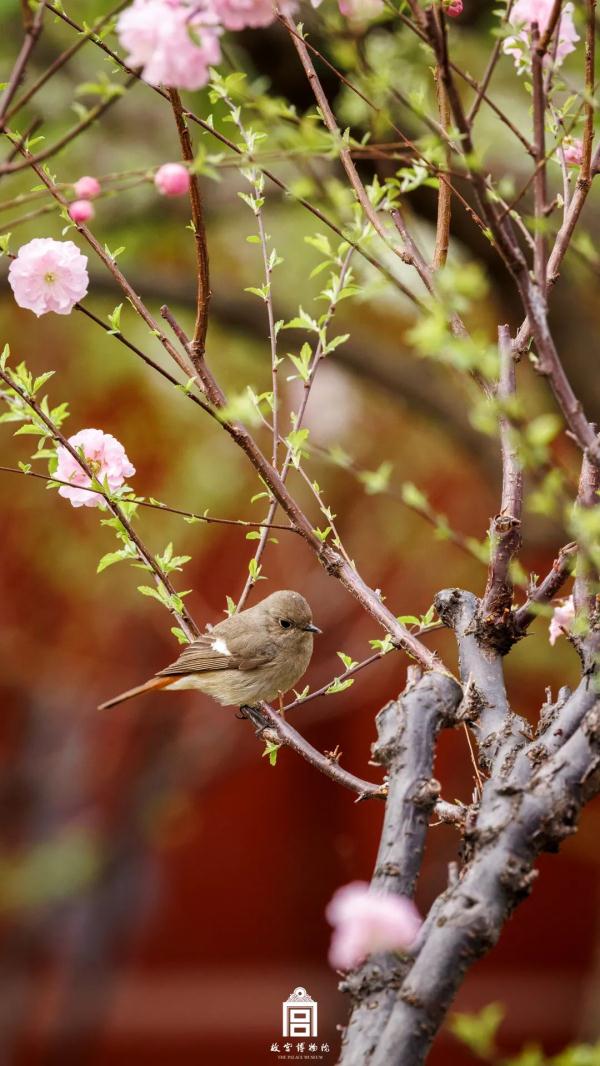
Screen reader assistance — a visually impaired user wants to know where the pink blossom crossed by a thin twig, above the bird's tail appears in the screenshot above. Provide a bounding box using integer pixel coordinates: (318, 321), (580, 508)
(54, 430), (135, 507)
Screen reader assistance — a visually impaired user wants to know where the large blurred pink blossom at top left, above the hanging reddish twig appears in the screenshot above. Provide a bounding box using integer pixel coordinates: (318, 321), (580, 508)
(116, 0), (221, 88)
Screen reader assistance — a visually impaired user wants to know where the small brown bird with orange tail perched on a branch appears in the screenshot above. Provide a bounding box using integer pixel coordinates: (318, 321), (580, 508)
(98, 591), (321, 711)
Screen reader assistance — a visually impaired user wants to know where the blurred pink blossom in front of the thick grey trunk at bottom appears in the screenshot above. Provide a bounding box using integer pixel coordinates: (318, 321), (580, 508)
(326, 881), (421, 970)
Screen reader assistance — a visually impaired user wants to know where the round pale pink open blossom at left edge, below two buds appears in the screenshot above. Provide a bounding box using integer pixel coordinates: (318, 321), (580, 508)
(9, 243), (90, 318)
